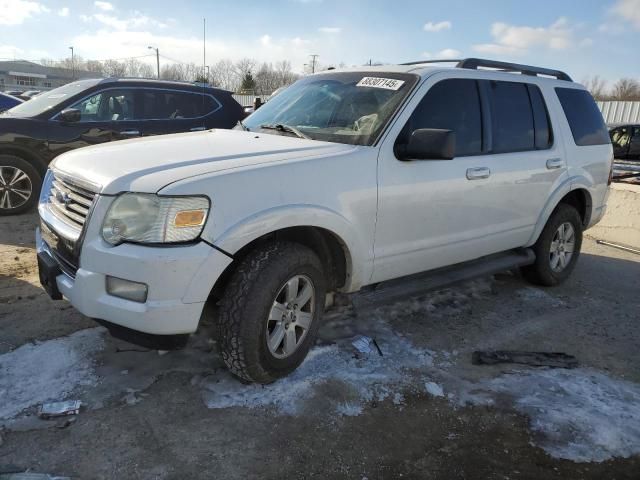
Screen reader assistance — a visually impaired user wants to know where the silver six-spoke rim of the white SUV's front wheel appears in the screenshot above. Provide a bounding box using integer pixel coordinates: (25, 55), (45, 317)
(266, 275), (316, 358)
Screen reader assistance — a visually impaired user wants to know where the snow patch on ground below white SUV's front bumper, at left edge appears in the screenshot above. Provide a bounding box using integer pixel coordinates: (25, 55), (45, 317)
(0, 328), (105, 419)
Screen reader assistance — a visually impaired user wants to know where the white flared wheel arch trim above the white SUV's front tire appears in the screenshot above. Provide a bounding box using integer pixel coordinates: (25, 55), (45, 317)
(203, 204), (373, 291)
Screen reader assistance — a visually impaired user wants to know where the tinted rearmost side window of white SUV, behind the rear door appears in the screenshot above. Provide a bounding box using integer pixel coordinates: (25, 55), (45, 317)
(556, 88), (610, 146)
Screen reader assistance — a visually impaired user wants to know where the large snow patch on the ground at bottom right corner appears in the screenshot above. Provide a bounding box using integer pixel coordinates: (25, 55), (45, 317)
(463, 369), (640, 462)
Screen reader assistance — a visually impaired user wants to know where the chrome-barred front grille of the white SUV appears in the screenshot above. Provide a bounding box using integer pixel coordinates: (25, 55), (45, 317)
(48, 174), (96, 230)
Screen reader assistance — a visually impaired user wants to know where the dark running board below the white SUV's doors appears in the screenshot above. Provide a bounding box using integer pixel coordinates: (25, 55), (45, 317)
(351, 248), (536, 309)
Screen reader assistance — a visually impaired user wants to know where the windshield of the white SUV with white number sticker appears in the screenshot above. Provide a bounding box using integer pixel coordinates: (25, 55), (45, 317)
(243, 72), (418, 145)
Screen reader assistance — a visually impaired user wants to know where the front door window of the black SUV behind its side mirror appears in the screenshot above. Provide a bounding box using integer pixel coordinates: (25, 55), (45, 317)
(71, 90), (135, 122)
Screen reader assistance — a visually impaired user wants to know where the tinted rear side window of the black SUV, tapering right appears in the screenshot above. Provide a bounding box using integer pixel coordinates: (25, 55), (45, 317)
(140, 90), (220, 120)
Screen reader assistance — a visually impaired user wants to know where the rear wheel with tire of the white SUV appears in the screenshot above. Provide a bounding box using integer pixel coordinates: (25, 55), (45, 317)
(522, 203), (582, 286)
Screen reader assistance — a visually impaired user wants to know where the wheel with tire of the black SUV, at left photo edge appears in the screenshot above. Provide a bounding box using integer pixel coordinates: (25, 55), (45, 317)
(0, 155), (42, 215)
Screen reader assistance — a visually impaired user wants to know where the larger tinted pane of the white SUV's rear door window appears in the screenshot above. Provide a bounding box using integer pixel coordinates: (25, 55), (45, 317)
(490, 81), (535, 153)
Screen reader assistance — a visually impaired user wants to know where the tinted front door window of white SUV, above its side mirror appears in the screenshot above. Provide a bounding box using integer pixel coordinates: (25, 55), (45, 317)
(399, 79), (482, 156)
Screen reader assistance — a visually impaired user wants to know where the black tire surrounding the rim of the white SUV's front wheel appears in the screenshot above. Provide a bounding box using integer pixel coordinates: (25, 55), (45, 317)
(218, 241), (326, 383)
